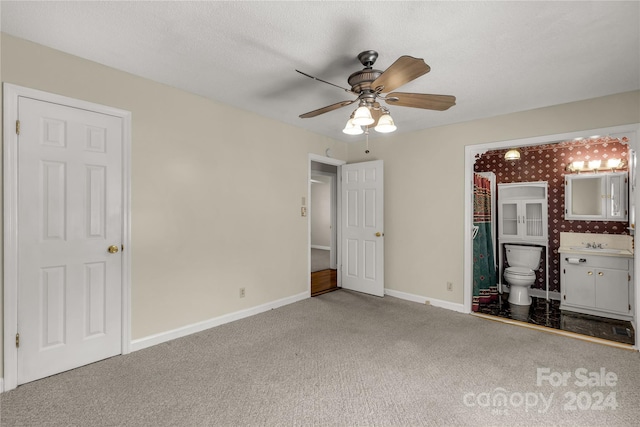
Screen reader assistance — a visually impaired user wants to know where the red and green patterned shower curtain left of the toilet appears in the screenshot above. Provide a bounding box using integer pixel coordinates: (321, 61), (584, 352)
(472, 174), (498, 311)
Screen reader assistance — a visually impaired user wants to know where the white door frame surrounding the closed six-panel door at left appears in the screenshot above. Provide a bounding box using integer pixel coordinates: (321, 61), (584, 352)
(0, 83), (131, 391)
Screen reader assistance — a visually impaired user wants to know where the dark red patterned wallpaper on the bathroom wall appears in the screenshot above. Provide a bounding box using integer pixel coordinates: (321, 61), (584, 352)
(474, 137), (628, 291)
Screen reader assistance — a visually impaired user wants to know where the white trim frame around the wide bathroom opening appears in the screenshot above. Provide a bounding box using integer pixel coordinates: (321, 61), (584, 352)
(463, 123), (640, 349)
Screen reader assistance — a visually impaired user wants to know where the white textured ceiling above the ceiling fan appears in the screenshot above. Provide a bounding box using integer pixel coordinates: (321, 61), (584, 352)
(0, 0), (640, 141)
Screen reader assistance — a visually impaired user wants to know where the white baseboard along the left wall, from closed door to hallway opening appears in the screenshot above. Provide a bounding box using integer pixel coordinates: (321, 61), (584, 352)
(131, 291), (310, 352)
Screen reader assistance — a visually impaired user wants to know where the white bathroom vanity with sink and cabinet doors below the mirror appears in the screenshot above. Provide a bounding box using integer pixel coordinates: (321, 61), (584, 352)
(558, 233), (633, 320)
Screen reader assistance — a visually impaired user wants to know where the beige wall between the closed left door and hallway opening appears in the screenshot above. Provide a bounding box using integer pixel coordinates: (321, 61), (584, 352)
(0, 34), (346, 368)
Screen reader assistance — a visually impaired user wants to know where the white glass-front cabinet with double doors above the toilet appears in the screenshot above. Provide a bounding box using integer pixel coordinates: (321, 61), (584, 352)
(498, 182), (548, 242)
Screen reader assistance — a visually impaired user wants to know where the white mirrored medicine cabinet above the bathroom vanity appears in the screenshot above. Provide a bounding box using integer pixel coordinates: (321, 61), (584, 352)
(564, 172), (628, 221)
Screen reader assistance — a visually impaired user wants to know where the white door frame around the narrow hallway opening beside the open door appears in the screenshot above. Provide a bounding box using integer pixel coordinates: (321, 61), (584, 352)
(303, 153), (347, 295)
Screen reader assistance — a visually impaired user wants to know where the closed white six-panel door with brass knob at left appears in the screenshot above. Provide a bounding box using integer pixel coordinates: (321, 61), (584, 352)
(17, 97), (123, 384)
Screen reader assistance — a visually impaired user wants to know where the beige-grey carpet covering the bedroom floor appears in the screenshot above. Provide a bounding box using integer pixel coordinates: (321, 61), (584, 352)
(0, 291), (640, 427)
